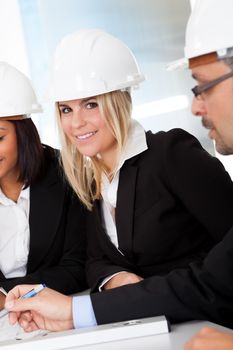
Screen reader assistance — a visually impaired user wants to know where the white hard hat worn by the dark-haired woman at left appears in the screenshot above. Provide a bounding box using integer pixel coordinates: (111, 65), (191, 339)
(0, 62), (42, 118)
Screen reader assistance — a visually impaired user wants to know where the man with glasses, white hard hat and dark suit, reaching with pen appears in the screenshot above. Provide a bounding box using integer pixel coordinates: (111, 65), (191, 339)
(3, 0), (233, 340)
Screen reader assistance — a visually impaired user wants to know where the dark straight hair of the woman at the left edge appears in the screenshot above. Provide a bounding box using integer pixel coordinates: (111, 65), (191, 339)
(10, 118), (44, 188)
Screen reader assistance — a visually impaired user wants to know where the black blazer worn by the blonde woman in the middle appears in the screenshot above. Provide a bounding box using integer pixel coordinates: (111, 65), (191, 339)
(87, 129), (233, 292)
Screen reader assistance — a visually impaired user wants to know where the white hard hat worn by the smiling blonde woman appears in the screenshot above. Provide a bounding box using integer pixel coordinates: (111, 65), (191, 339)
(49, 29), (144, 101)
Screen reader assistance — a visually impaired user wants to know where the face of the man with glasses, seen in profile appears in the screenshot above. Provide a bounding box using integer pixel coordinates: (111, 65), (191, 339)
(192, 61), (233, 155)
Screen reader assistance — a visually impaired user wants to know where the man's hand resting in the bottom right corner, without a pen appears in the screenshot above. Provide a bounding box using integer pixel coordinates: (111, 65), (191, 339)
(185, 327), (233, 350)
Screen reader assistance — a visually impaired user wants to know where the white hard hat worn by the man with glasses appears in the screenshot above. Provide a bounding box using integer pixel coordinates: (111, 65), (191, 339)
(168, 0), (233, 69)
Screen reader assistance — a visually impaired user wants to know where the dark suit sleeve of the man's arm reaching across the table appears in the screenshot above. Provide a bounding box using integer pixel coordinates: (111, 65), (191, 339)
(91, 224), (233, 328)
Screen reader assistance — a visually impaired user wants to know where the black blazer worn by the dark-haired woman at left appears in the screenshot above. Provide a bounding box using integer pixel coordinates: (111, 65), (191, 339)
(0, 146), (86, 294)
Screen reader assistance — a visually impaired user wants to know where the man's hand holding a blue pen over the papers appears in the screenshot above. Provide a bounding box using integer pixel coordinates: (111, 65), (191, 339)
(5, 285), (74, 332)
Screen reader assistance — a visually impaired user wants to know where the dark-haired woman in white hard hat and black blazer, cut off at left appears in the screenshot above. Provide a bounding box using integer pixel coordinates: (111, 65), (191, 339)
(0, 62), (86, 300)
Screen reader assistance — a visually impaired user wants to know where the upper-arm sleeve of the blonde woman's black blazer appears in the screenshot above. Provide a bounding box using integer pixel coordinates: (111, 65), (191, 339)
(161, 129), (233, 242)
